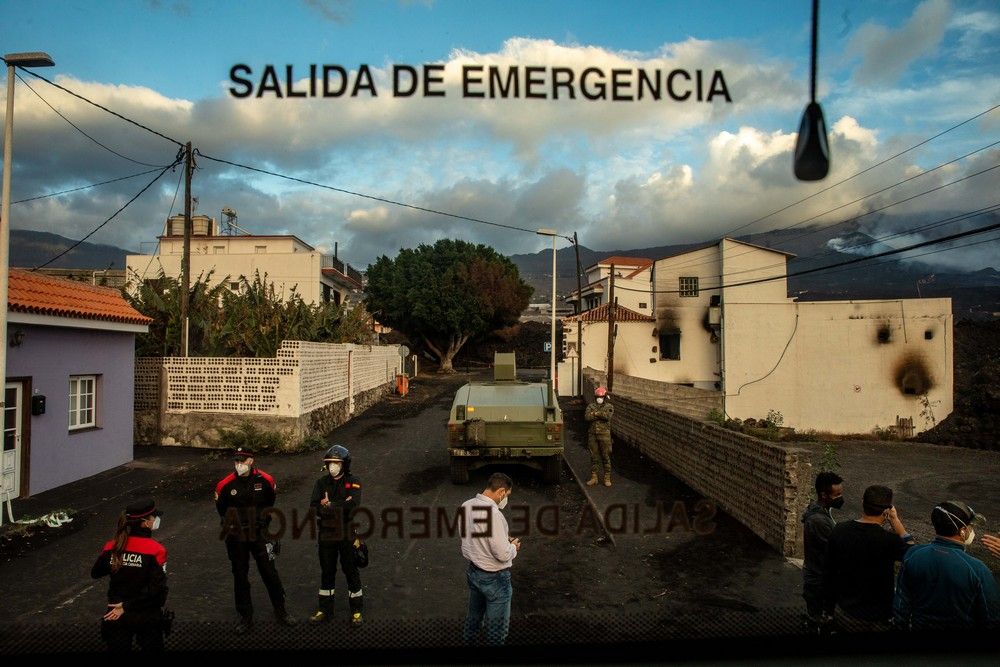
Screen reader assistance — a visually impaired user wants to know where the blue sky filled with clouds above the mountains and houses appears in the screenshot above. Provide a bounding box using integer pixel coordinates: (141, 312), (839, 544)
(3, 0), (1000, 269)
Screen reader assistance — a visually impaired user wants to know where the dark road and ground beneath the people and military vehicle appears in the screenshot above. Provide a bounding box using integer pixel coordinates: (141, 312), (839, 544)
(0, 374), (1000, 662)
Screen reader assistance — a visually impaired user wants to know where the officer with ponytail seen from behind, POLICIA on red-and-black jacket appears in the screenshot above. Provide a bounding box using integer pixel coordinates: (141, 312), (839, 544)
(90, 498), (167, 652)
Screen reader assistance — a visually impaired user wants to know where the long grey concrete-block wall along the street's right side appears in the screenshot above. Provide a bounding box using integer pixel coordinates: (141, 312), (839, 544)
(586, 373), (812, 558)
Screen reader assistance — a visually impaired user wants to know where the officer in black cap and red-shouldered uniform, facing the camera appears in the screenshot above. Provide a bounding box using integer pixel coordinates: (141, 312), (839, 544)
(215, 447), (295, 635)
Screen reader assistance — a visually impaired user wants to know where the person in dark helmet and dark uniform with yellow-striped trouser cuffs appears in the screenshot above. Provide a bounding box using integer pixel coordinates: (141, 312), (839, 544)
(309, 445), (364, 627)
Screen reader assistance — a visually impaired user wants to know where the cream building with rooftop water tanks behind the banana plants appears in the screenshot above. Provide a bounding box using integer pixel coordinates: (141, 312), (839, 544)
(126, 215), (362, 304)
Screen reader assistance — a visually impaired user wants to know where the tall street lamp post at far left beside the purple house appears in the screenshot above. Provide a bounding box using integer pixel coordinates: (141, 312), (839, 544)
(0, 51), (55, 409)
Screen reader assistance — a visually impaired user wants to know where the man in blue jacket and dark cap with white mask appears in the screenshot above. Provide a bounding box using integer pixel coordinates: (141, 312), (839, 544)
(893, 500), (1000, 631)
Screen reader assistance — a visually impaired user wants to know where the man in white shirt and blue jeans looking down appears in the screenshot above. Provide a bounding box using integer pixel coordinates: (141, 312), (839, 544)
(461, 472), (521, 645)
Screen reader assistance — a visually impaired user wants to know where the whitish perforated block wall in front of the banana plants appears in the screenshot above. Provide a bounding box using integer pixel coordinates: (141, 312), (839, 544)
(135, 341), (400, 447)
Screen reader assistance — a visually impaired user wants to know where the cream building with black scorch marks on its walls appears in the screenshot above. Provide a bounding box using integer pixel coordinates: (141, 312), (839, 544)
(564, 238), (954, 433)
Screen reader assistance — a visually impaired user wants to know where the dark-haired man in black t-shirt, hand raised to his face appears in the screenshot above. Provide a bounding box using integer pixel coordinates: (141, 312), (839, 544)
(823, 485), (913, 632)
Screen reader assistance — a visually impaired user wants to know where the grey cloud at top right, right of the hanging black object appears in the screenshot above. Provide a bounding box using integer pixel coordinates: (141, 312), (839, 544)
(847, 0), (951, 85)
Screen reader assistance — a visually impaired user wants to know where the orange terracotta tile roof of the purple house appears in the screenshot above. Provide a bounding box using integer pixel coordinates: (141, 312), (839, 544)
(7, 269), (153, 324)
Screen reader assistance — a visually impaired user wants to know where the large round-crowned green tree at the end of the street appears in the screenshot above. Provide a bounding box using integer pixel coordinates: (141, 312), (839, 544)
(365, 239), (532, 373)
